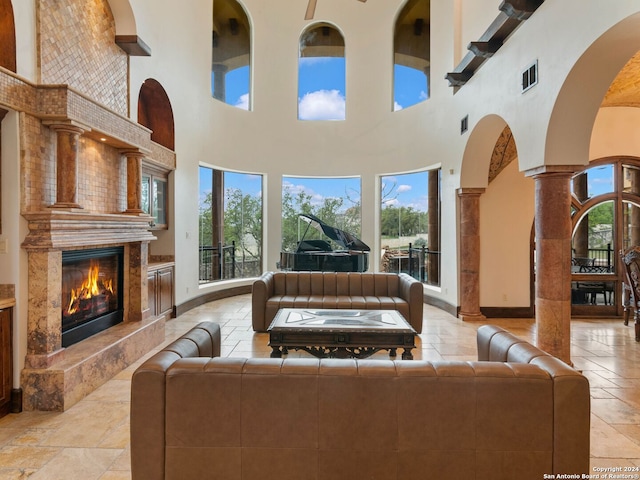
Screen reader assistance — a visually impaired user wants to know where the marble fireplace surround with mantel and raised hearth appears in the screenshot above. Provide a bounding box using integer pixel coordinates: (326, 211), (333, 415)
(21, 209), (165, 411)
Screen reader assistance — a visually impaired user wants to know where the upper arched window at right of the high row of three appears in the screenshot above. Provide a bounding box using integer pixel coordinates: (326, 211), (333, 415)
(393, 0), (431, 110)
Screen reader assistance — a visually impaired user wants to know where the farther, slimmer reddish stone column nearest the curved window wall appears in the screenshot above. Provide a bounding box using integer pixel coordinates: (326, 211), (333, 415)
(458, 188), (486, 321)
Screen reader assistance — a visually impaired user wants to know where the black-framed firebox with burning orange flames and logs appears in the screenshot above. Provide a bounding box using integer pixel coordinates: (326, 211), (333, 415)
(61, 247), (124, 347)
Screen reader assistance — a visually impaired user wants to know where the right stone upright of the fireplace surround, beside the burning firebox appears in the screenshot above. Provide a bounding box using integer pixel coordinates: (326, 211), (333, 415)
(124, 242), (149, 322)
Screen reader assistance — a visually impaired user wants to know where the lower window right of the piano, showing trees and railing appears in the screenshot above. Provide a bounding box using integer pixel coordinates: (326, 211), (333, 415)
(380, 168), (441, 286)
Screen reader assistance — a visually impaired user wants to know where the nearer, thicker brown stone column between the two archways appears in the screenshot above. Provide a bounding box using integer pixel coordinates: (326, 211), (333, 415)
(528, 166), (575, 364)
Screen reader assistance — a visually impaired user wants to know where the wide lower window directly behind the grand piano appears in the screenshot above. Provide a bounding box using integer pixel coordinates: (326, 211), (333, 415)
(282, 177), (361, 252)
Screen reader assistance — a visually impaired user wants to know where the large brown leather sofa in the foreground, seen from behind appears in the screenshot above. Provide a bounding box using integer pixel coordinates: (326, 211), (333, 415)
(131, 323), (590, 480)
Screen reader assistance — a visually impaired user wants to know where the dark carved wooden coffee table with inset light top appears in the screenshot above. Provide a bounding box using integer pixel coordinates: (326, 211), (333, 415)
(267, 308), (416, 360)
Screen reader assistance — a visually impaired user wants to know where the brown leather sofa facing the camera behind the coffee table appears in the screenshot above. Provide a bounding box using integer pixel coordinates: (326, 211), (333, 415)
(251, 272), (424, 333)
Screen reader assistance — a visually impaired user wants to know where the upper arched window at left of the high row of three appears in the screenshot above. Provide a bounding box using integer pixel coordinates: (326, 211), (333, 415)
(211, 0), (251, 110)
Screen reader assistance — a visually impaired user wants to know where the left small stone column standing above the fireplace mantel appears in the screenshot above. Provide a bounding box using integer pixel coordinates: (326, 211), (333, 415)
(49, 123), (85, 208)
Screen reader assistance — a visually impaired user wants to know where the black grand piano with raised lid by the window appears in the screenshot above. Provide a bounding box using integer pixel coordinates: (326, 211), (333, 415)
(279, 213), (371, 272)
